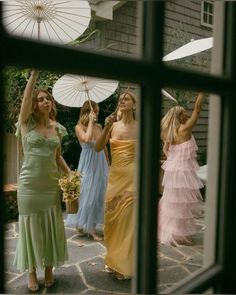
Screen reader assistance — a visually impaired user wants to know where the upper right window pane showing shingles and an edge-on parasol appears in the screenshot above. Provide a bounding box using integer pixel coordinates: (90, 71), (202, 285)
(163, 1), (213, 72)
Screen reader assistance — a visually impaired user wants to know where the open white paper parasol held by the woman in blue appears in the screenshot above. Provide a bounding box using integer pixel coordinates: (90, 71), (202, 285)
(52, 74), (119, 107)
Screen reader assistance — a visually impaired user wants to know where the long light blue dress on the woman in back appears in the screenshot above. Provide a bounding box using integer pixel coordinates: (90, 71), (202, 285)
(66, 141), (108, 233)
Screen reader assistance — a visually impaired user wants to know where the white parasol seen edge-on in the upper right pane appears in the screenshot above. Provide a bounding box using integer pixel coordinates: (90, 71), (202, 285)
(162, 37), (213, 61)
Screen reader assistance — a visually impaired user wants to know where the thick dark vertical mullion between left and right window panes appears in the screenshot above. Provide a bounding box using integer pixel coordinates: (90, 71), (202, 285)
(133, 1), (165, 294)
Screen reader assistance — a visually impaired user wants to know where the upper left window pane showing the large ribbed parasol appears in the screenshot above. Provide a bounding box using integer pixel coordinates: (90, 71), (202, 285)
(3, 1), (141, 58)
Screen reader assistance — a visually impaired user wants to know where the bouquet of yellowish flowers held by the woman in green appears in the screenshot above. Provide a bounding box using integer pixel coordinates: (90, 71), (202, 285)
(59, 171), (80, 214)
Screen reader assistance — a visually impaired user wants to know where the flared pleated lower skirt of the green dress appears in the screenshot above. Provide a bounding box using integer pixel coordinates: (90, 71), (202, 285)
(14, 206), (68, 272)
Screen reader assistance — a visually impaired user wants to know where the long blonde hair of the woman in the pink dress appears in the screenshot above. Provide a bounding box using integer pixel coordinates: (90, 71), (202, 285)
(161, 106), (185, 143)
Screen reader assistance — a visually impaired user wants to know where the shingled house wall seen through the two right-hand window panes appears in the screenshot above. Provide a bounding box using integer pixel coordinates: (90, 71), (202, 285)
(163, 0), (212, 160)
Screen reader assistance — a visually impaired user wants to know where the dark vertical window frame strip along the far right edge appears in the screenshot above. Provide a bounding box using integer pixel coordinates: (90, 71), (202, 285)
(216, 1), (236, 294)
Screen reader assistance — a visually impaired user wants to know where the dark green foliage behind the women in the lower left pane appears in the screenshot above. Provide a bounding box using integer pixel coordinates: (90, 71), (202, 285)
(4, 67), (118, 169)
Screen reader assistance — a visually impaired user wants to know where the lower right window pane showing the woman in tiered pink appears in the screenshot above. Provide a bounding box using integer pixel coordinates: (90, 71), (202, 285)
(158, 88), (218, 293)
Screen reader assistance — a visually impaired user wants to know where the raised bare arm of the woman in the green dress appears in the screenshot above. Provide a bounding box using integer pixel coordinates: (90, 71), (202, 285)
(19, 70), (38, 125)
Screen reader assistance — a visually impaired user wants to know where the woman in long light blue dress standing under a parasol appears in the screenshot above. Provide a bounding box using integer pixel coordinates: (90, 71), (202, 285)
(66, 101), (109, 241)
